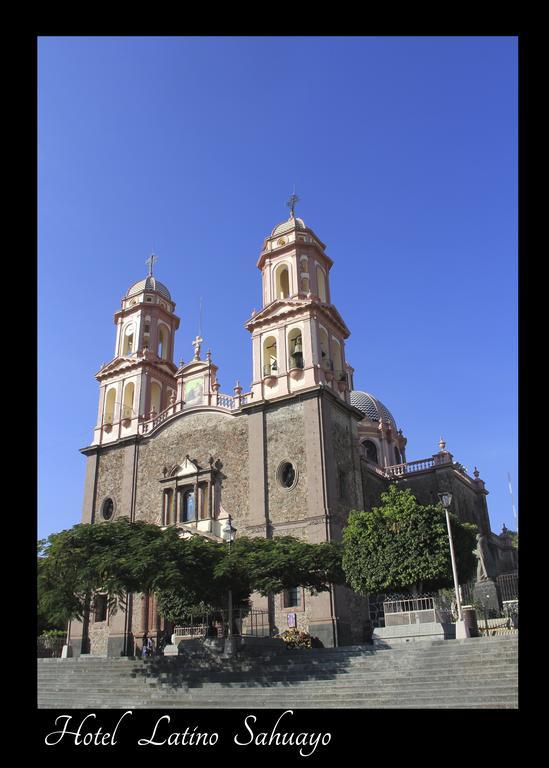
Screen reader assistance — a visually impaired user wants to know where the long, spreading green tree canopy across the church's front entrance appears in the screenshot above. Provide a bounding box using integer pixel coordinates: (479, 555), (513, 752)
(38, 518), (344, 624)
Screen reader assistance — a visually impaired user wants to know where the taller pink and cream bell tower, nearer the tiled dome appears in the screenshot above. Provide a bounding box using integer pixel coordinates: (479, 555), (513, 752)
(246, 194), (352, 402)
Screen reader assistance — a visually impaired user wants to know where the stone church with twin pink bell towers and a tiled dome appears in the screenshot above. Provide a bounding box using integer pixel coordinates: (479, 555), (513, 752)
(71, 200), (513, 656)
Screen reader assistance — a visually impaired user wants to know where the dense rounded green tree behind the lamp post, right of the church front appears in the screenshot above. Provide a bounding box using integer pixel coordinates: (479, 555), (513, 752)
(343, 484), (476, 595)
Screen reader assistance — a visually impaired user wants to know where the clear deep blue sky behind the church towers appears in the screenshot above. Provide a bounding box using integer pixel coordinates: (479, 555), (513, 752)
(38, 37), (518, 536)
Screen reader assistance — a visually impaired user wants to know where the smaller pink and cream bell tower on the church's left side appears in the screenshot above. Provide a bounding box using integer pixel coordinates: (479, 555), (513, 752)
(92, 254), (179, 445)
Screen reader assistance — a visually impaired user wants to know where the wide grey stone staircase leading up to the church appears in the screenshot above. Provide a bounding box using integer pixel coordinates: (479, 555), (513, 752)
(38, 636), (518, 709)
